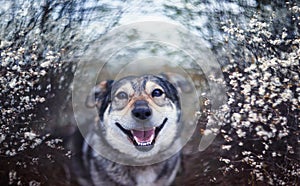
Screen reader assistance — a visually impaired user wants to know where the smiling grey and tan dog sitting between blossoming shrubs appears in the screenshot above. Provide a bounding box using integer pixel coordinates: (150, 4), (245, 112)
(76, 73), (190, 186)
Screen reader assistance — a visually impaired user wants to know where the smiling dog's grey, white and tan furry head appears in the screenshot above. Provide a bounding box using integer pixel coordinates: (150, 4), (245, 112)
(85, 75), (191, 158)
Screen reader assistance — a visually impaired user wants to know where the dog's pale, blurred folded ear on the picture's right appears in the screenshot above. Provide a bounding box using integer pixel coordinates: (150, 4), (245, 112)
(160, 72), (193, 93)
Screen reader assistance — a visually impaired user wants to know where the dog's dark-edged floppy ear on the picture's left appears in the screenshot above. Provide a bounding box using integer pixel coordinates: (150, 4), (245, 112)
(85, 80), (113, 109)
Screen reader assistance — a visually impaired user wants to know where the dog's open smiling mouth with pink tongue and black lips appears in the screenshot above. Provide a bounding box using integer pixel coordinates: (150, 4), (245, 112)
(116, 118), (168, 148)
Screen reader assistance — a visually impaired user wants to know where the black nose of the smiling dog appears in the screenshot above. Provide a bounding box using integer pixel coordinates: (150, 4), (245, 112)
(131, 100), (152, 120)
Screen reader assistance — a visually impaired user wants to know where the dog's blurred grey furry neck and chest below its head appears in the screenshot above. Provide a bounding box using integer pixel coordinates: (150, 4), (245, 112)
(84, 131), (180, 186)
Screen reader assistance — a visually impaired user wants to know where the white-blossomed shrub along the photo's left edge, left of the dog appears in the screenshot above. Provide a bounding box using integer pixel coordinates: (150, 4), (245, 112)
(0, 45), (74, 185)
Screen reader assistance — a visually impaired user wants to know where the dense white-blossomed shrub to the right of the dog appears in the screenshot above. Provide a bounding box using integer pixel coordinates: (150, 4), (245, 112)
(220, 3), (300, 185)
